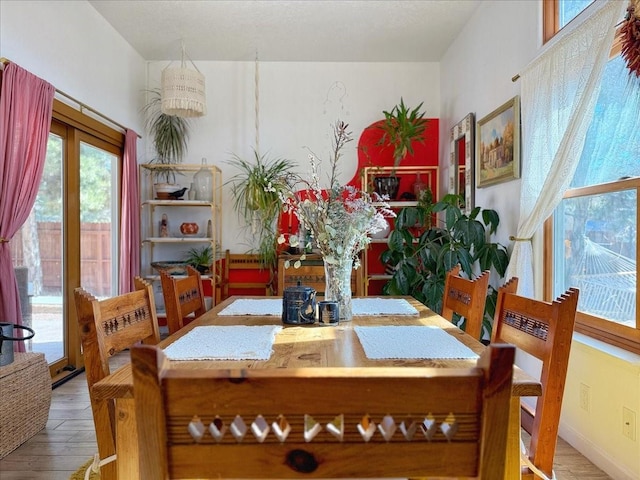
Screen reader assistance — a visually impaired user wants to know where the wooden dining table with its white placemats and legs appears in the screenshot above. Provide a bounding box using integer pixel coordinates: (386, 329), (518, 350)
(93, 296), (542, 480)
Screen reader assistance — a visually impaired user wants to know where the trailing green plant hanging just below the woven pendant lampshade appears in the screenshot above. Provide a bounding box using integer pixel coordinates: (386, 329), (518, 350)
(142, 89), (191, 187)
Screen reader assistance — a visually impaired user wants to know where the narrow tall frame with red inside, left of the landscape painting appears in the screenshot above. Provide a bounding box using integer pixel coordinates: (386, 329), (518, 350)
(449, 113), (475, 215)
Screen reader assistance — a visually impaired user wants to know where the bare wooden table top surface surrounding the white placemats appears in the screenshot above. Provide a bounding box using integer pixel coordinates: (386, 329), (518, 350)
(93, 296), (542, 399)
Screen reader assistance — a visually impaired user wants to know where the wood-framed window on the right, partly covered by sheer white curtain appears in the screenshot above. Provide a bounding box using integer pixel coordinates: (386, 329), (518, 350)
(545, 0), (640, 353)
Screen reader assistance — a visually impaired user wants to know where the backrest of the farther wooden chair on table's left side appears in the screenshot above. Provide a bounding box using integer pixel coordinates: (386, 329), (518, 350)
(160, 265), (207, 334)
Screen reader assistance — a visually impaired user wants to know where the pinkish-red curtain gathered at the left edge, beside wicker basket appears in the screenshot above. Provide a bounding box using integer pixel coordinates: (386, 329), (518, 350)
(0, 63), (55, 352)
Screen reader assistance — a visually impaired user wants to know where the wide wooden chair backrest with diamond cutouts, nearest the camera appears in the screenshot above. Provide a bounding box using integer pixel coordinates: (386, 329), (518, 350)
(131, 345), (515, 480)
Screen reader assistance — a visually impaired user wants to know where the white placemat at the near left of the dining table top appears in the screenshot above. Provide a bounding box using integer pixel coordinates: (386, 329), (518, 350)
(164, 325), (282, 360)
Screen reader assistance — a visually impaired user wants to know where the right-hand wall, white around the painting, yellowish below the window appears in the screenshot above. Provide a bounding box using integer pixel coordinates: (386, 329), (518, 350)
(440, 0), (640, 480)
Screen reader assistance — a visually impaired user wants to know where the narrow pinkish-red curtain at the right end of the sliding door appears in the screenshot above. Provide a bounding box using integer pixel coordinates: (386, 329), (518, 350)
(120, 130), (140, 293)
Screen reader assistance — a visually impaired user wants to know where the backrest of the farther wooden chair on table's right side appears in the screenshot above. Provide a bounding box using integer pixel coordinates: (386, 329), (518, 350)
(442, 265), (490, 340)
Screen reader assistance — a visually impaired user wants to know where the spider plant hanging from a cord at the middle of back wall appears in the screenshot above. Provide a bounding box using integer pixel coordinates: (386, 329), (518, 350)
(226, 150), (295, 270)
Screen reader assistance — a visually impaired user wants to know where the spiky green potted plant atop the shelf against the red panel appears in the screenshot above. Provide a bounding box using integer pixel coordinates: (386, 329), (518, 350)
(374, 97), (428, 199)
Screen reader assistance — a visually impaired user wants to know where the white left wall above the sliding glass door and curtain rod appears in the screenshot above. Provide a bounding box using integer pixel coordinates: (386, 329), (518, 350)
(0, 0), (146, 139)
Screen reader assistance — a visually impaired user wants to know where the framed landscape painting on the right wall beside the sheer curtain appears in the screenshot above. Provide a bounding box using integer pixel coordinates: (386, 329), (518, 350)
(476, 95), (521, 188)
